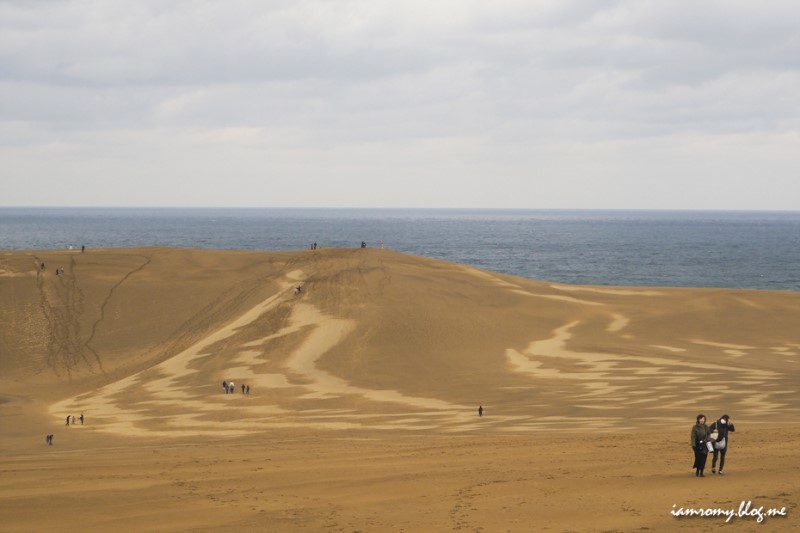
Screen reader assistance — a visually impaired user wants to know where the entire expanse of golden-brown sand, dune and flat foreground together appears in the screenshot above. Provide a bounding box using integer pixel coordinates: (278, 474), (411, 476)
(0, 248), (800, 532)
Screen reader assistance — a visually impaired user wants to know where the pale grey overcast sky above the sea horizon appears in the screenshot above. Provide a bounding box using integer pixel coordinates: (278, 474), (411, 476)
(0, 0), (800, 210)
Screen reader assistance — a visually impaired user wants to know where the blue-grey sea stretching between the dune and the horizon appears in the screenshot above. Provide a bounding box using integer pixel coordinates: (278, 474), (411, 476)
(0, 208), (800, 291)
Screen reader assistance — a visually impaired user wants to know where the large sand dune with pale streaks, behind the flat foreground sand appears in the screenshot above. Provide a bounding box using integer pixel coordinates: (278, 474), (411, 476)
(0, 248), (800, 437)
